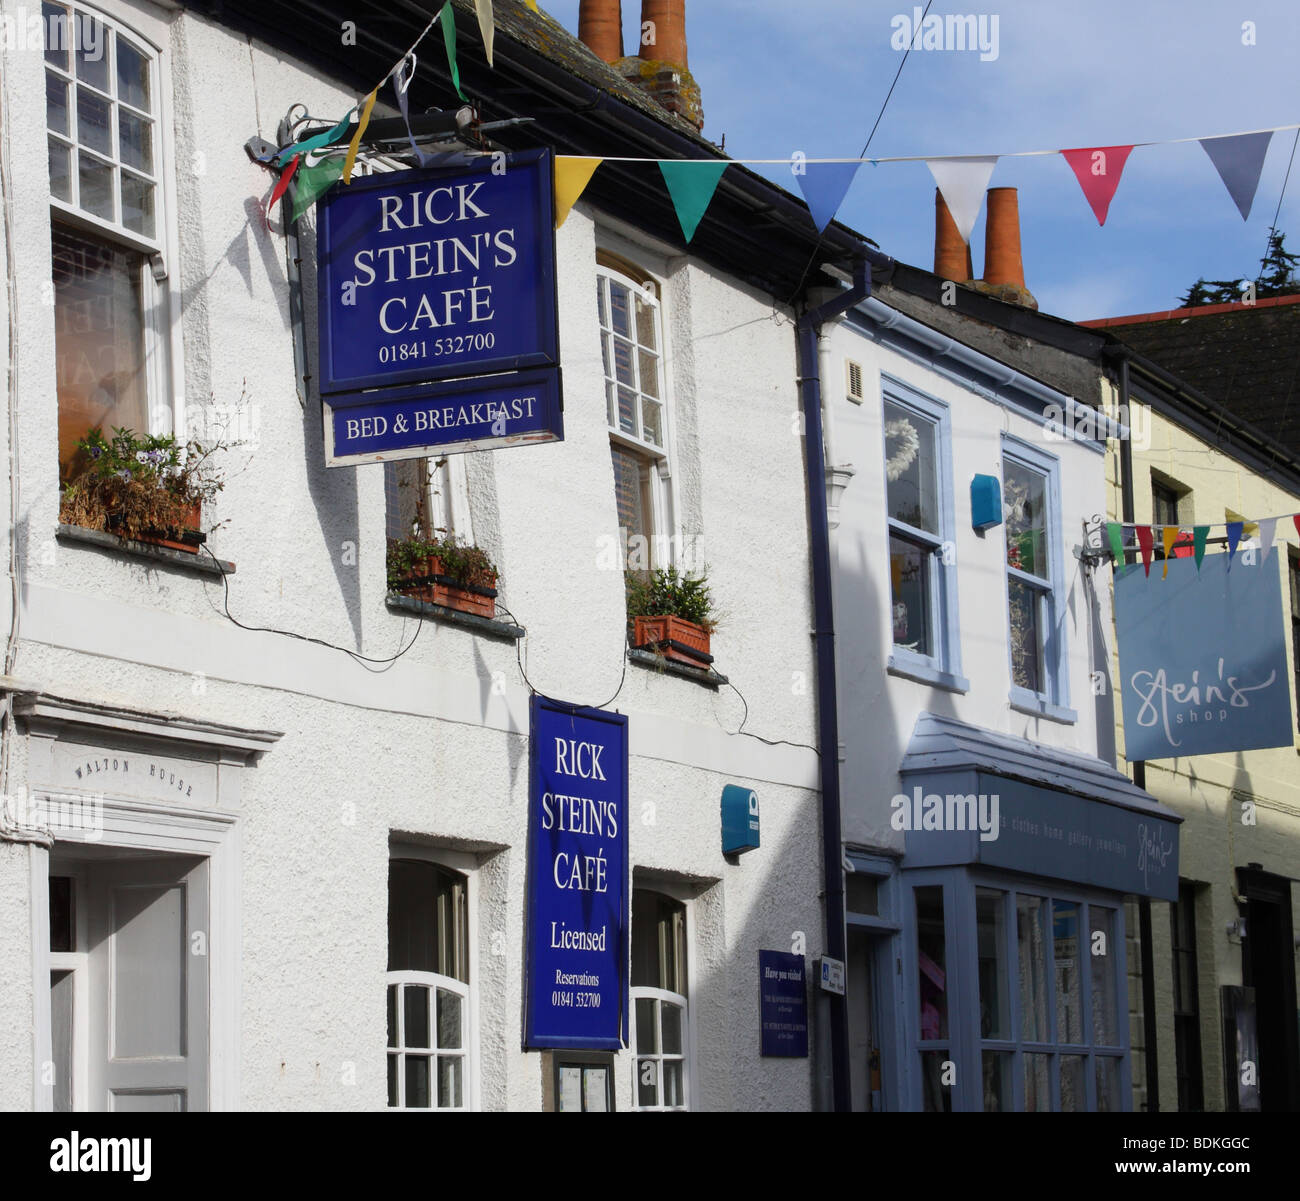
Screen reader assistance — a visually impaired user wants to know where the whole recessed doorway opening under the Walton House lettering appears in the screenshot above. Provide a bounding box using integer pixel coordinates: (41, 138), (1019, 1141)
(47, 846), (209, 1113)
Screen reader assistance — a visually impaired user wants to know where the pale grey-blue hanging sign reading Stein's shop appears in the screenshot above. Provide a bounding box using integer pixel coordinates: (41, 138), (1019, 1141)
(1115, 550), (1295, 762)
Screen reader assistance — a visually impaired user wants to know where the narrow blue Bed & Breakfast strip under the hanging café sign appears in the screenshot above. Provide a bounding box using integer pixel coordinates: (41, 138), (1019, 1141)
(325, 369), (564, 467)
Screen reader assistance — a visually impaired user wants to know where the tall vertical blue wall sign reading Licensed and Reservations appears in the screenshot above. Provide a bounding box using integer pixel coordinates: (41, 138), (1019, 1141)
(524, 695), (629, 1050)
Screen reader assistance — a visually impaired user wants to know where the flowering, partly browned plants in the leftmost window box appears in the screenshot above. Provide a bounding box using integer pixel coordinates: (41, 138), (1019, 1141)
(59, 426), (226, 554)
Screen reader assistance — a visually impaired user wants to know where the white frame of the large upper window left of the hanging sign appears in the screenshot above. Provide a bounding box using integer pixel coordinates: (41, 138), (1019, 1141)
(42, 0), (182, 442)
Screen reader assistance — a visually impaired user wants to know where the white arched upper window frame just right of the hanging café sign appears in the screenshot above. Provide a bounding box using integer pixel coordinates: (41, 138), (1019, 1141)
(595, 239), (689, 568)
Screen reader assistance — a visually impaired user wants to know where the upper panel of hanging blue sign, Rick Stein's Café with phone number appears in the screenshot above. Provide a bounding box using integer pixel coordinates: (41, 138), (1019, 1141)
(317, 149), (559, 396)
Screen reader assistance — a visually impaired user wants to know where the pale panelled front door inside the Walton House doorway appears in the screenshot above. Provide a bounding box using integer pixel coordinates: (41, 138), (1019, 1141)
(83, 855), (208, 1113)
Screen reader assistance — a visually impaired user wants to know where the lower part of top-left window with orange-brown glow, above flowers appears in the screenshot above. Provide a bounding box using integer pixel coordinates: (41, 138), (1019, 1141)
(51, 225), (148, 482)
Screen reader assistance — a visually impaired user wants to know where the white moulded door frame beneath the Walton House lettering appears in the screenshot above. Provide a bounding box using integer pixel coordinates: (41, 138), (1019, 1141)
(29, 790), (239, 1113)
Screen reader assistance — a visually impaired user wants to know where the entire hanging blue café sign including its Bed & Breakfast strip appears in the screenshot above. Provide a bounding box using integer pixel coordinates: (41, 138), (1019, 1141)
(317, 149), (564, 467)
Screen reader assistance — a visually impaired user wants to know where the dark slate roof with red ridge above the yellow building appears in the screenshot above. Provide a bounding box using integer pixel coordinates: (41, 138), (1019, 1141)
(1080, 295), (1300, 458)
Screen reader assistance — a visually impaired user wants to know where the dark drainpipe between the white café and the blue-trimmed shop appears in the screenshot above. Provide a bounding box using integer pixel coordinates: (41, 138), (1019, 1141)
(798, 251), (892, 1113)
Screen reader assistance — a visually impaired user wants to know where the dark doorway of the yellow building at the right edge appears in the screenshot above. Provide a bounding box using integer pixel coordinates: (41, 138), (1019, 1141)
(1238, 867), (1300, 1113)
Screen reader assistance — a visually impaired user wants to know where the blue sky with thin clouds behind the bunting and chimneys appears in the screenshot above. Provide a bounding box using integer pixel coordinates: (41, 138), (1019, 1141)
(541, 0), (1300, 320)
